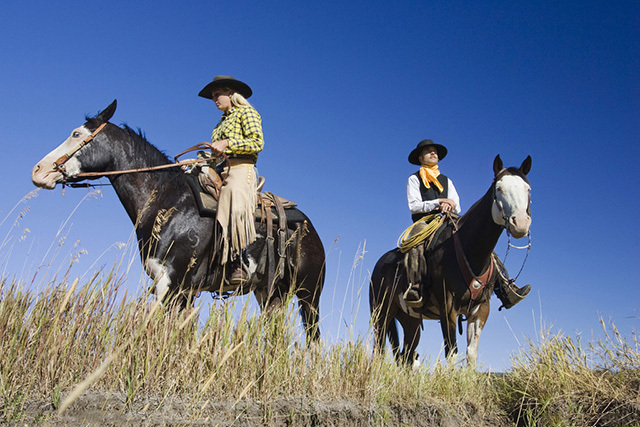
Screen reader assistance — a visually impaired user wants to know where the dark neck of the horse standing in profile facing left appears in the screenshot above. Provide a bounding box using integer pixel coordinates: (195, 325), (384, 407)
(104, 131), (180, 224)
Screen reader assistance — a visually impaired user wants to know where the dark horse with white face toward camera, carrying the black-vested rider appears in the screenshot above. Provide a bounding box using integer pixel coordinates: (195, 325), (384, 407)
(369, 156), (531, 366)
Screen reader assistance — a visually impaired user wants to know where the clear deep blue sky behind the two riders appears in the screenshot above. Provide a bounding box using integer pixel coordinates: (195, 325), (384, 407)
(0, 0), (640, 369)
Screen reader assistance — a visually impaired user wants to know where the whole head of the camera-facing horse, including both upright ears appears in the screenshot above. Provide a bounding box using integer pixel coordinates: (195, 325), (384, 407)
(491, 155), (531, 239)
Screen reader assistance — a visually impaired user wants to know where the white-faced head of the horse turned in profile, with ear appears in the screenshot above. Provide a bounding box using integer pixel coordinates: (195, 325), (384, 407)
(31, 100), (117, 190)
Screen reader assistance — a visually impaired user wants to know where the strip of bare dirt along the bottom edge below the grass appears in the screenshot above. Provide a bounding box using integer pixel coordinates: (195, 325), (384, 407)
(2, 391), (513, 427)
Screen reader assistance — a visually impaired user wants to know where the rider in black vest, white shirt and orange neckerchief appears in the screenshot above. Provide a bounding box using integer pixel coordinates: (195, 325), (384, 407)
(405, 139), (531, 308)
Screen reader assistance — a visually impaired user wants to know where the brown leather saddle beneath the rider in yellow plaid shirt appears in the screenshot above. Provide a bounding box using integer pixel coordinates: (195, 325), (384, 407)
(186, 160), (306, 292)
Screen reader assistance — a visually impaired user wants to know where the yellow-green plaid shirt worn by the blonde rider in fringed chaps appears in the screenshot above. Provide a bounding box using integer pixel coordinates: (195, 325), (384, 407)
(211, 106), (264, 161)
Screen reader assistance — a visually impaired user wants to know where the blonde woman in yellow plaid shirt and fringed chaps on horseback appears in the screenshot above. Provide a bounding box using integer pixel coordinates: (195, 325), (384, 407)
(198, 76), (264, 285)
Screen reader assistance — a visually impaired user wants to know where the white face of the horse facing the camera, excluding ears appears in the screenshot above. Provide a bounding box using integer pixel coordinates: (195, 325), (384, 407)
(491, 175), (531, 238)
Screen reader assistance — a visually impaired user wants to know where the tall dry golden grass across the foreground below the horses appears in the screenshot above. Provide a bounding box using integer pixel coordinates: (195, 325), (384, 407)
(0, 192), (640, 426)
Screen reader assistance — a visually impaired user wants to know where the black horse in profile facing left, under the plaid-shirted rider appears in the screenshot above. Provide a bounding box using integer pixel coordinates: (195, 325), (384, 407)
(32, 101), (325, 340)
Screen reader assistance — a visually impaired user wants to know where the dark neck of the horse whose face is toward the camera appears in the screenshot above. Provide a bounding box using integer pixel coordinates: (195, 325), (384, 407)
(457, 187), (502, 274)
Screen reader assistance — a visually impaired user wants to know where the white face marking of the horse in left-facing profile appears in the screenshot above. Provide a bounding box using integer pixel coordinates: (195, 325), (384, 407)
(31, 126), (91, 190)
